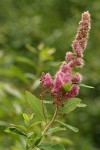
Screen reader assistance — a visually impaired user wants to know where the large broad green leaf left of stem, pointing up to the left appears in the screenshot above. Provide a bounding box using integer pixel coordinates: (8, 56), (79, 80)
(26, 91), (47, 121)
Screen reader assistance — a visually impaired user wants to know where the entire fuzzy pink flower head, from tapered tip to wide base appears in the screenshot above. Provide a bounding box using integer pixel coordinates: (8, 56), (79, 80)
(40, 12), (90, 106)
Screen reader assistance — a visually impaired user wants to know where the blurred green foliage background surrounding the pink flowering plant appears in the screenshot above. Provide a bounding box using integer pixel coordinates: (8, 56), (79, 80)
(0, 0), (100, 150)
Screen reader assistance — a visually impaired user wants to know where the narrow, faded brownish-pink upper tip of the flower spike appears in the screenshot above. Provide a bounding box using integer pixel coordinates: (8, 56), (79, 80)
(72, 11), (91, 57)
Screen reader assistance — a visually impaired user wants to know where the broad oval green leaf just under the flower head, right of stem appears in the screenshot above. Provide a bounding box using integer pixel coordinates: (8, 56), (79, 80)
(60, 98), (81, 114)
